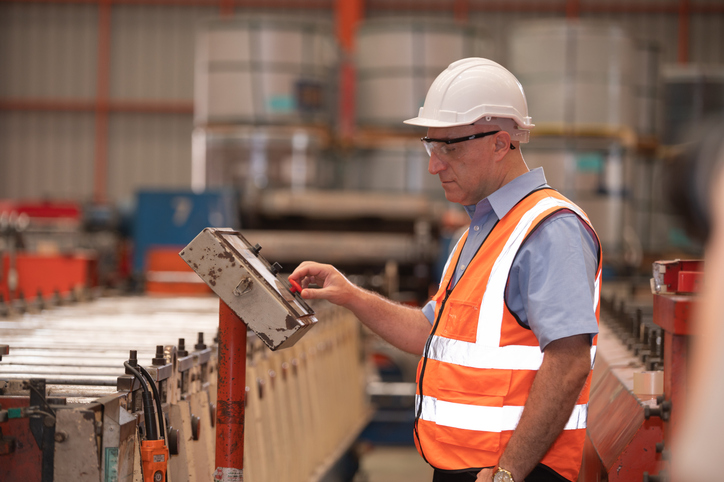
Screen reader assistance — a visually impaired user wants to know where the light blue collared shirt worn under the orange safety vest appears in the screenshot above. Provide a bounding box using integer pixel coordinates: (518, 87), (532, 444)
(423, 168), (599, 350)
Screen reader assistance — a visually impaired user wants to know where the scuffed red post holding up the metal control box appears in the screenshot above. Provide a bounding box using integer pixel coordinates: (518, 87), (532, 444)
(214, 300), (247, 482)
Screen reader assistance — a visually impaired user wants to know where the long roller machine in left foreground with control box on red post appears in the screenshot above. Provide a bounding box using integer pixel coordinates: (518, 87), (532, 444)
(0, 230), (370, 482)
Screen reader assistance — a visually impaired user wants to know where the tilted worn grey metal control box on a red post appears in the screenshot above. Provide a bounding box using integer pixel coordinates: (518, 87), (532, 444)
(179, 228), (317, 350)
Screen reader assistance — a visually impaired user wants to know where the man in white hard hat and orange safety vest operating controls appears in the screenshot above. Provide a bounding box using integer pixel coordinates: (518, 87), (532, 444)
(290, 58), (601, 482)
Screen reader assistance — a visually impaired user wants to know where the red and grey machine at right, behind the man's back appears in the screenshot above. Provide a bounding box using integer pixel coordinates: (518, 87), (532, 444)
(579, 260), (703, 482)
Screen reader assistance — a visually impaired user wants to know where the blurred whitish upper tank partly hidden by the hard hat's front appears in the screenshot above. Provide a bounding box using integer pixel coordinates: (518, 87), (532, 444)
(356, 18), (490, 129)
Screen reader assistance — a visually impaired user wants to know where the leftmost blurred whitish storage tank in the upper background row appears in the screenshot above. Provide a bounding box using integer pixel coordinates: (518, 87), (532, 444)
(194, 15), (338, 125)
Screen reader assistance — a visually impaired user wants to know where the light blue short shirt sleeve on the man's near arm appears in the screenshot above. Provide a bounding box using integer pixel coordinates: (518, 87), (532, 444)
(506, 211), (599, 351)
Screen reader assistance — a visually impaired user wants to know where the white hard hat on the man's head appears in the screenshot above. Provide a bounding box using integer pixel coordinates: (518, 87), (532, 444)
(405, 57), (534, 142)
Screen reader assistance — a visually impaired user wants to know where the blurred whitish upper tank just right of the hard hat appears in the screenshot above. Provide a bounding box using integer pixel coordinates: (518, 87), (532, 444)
(509, 19), (636, 134)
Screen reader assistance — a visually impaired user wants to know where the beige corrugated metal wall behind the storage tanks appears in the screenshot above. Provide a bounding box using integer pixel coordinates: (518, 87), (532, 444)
(0, 0), (724, 202)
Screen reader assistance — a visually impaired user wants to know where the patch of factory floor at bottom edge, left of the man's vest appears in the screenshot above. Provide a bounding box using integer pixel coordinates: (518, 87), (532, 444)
(354, 446), (432, 482)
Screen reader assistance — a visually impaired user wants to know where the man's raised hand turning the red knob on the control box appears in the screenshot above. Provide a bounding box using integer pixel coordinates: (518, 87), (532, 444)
(289, 261), (357, 306)
